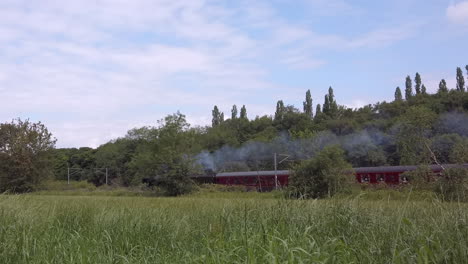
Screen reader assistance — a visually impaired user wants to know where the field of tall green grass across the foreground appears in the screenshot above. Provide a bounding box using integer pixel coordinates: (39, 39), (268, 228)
(0, 193), (468, 263)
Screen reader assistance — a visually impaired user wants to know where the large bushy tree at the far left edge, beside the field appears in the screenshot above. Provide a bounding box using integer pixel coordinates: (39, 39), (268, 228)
(0, 118), (56, 192)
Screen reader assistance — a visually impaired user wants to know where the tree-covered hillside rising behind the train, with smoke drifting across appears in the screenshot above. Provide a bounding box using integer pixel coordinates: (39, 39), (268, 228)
(48, 66), (468, 185)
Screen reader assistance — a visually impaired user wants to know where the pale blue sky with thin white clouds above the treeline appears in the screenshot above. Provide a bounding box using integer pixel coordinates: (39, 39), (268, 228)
(0, 0), (468, 147)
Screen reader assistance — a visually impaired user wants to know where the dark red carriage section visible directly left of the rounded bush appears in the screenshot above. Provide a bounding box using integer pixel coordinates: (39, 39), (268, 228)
(215, 170), (289, 191)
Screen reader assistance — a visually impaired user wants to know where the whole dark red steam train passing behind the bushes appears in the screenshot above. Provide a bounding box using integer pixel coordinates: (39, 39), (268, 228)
(187, 164), (468, 191)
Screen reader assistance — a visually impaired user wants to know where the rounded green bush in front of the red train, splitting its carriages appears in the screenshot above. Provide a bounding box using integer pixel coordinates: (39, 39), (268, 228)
(289, 145), (352, 198)
